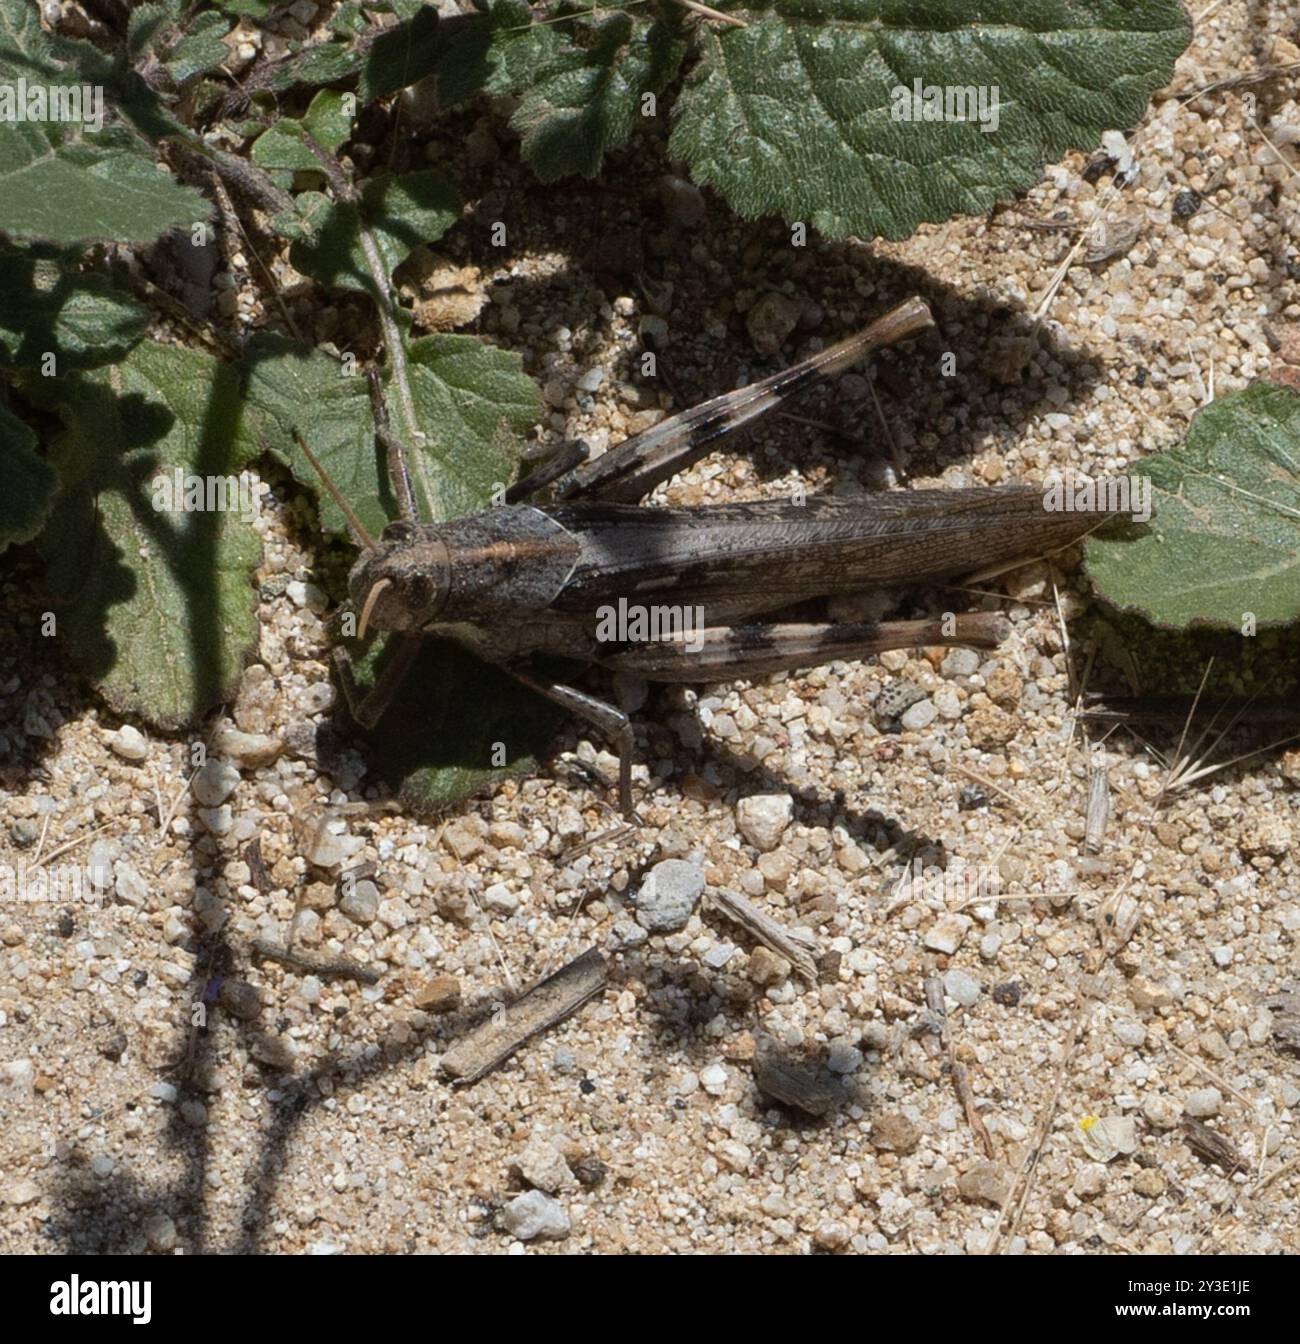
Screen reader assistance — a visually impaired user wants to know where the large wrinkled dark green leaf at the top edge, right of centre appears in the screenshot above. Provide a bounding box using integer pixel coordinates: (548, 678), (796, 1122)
(669, 0), (1191, 238)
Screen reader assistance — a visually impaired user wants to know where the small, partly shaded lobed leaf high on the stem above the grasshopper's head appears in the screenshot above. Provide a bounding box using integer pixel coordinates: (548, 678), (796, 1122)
(289, 170), (461, 294)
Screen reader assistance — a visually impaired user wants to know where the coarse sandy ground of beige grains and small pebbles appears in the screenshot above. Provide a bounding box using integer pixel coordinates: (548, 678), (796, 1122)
(0, 3), (1300, 1253)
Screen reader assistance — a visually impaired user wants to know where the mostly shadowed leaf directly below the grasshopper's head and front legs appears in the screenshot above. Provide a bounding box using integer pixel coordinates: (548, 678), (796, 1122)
(354, 640), (561, 814)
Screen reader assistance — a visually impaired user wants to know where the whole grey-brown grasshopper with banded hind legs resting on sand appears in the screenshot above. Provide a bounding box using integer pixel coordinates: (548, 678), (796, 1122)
(297, 298), (1106, 817)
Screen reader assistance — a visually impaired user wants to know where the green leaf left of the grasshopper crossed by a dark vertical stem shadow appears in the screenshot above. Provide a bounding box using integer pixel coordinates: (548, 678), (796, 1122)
(24, 343), (261, 730)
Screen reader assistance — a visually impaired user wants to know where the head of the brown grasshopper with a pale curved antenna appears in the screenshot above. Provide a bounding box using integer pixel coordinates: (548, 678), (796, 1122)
(348, 523), (450, 638)
